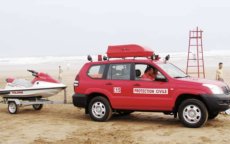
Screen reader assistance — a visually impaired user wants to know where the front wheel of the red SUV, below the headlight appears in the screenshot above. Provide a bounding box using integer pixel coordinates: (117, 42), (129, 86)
(178, 99), (208, 128)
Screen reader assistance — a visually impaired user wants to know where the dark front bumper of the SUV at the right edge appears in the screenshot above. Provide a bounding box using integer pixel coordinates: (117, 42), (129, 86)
(202, 94), (230, 112)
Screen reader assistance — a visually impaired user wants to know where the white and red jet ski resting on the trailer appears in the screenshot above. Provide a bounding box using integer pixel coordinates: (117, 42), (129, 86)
(0, 70), (66, 99)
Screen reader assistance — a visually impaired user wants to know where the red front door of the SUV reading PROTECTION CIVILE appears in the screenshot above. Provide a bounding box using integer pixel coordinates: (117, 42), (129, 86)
(127, 64), (172, 111)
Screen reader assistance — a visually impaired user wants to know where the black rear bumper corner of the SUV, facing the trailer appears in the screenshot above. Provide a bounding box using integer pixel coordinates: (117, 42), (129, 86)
(72, 94), (87, 108)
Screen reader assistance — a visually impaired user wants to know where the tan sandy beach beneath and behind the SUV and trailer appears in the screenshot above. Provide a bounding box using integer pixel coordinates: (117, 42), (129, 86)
(0, 62), (230, 144)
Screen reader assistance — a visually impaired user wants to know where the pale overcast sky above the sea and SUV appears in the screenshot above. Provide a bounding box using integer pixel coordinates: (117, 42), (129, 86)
(0, 0), (230, 57)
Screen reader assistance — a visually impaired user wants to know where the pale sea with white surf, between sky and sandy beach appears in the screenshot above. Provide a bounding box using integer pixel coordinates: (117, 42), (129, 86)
(0, 50), (230, 72)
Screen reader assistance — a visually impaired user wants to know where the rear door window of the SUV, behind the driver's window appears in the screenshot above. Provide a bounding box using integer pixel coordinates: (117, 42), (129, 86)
(107, 64), (131, 80)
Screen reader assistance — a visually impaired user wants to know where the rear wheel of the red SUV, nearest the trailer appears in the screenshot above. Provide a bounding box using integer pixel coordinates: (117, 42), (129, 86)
(88, 96), (112, 122)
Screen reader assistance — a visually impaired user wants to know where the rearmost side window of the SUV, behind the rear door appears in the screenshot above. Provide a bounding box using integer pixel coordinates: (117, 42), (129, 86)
(88, 65), (105, 79)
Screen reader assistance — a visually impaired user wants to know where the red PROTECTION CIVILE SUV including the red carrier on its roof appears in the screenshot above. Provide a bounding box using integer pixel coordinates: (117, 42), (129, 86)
(72, 45), (230, 128)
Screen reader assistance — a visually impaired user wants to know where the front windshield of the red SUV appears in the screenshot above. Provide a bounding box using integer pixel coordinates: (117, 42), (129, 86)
(158, 63), (188, 78)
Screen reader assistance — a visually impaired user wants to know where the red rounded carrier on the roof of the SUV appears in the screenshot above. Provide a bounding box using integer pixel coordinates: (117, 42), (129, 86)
(107, 44), (154, 58)
